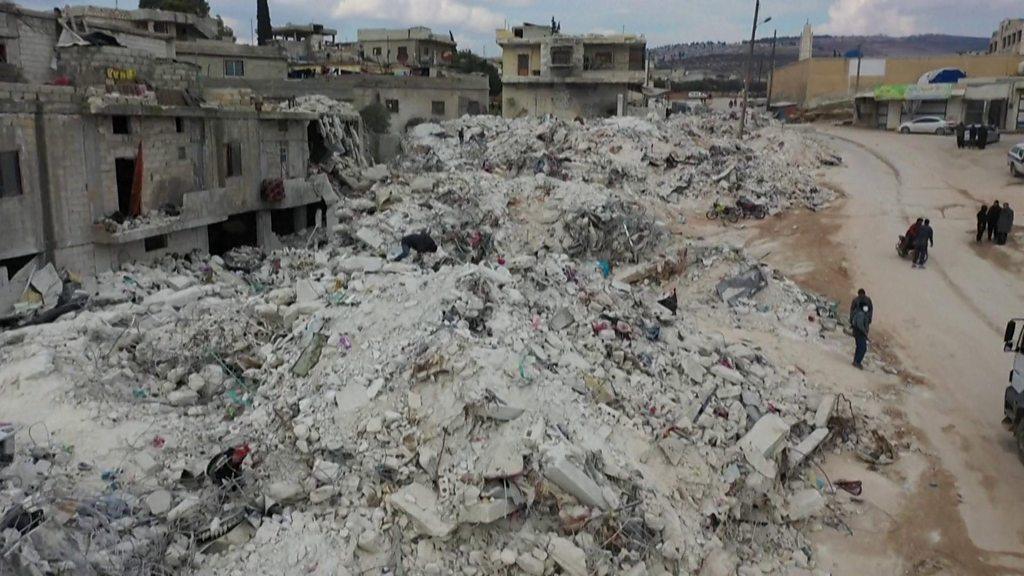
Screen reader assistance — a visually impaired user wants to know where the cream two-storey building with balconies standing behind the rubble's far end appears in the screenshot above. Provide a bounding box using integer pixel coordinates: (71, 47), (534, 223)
(497, 24), (647, 119)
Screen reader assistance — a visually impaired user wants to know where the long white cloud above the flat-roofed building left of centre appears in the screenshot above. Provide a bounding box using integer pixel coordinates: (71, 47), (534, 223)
(334, 0), (505, 34)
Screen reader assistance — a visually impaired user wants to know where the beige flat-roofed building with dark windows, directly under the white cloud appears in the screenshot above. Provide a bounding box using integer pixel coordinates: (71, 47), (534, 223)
(356, 26), (457, 70)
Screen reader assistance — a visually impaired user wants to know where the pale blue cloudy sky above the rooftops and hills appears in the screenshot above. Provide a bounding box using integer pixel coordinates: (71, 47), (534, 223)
(19, 0), (1024, 55)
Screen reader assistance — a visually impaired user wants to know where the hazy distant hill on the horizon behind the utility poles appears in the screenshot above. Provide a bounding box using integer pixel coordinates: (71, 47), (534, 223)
(650, 34), (988, 78)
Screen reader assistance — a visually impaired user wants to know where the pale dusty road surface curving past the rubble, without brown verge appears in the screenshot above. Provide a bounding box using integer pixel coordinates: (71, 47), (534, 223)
(822, 128), (1024, 574)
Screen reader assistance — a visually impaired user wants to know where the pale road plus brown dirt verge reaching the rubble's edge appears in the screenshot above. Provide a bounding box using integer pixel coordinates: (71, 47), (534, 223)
(751, 127), (1024, 575)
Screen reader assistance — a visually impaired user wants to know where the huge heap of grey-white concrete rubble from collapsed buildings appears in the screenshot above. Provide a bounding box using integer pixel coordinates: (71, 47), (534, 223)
(0, 107), (888, 576)
